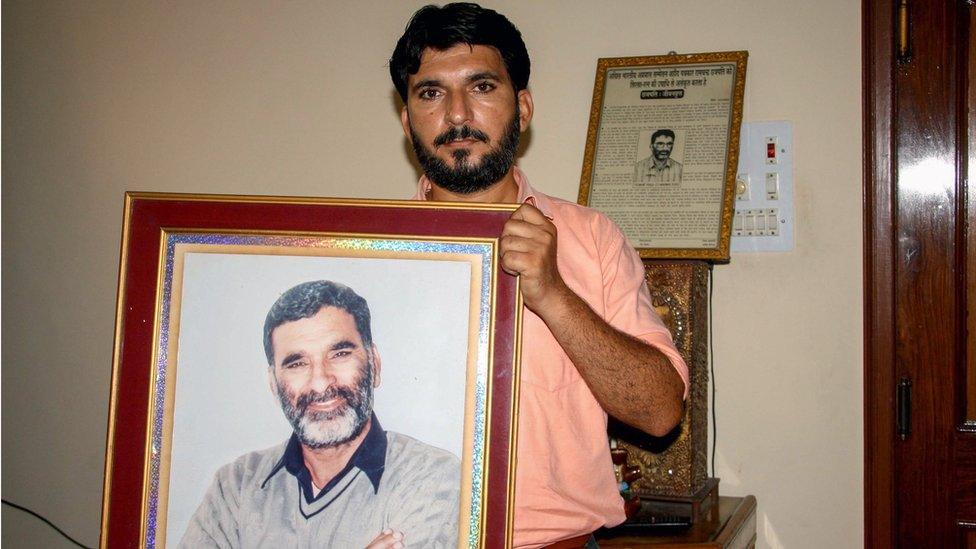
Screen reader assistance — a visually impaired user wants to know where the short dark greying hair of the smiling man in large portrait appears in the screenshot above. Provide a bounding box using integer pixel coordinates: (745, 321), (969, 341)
(264, 280), (373, 366)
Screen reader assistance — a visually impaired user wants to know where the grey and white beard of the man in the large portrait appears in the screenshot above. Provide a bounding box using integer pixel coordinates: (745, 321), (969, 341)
(277, 357), (373, 449)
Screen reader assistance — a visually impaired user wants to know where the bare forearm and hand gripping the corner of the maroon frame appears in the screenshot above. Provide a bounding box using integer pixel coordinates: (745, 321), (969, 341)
(501, 204), (684, 436)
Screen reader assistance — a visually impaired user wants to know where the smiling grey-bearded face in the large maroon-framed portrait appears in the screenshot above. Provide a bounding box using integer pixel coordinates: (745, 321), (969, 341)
(271, 307), (380, 448)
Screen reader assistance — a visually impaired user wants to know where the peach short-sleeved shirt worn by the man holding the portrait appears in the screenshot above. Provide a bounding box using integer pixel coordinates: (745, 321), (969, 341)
(414, 168), (688, 548)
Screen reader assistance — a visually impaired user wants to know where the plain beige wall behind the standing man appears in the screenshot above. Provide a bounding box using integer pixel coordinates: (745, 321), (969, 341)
(2, 0), (862, 547)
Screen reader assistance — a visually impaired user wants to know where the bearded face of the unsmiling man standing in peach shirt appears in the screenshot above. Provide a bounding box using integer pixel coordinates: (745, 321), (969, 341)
(401, 44), (532, 194)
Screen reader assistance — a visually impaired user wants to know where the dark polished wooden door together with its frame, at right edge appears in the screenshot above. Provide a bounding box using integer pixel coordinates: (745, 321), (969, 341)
(861, 0), (976, 547)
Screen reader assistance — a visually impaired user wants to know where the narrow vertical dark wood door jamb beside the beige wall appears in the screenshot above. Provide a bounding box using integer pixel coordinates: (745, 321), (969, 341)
(861, 0), (896, 548)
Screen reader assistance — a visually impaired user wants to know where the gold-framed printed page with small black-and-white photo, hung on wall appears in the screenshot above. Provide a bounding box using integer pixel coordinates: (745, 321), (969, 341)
(578, 51), (748, 262)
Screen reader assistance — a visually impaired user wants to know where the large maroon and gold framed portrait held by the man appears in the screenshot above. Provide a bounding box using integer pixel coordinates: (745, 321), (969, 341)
(100, 193), (521, 548)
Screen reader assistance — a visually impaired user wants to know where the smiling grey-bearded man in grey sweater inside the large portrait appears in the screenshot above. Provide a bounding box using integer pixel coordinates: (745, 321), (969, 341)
(180, 280), (460, 549)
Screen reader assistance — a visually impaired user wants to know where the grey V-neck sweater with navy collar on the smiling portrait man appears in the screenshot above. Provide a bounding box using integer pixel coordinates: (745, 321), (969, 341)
(180, 415), (461, 548)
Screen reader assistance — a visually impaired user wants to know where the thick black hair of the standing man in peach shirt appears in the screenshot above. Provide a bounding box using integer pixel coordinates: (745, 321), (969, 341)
(390, 2), (529, 103)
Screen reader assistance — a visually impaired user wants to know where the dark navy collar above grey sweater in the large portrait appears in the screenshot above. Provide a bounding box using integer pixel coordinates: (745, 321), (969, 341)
(261, 413), (387, 501)
